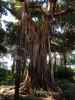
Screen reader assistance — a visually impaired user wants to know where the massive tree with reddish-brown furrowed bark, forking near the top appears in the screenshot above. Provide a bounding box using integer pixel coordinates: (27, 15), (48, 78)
(15, 0), (75, 99)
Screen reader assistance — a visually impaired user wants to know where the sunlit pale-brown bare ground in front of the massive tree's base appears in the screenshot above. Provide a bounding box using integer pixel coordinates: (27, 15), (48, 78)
(0, 85), (61, 100)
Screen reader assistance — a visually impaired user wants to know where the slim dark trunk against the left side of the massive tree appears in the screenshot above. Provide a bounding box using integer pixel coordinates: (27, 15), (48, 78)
(14, 24), (22, 100)
